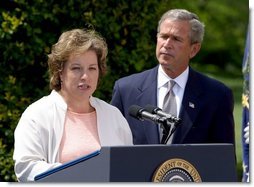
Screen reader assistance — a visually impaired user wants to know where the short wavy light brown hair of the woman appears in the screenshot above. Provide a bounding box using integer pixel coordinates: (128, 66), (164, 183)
(48, 29), (108, 91)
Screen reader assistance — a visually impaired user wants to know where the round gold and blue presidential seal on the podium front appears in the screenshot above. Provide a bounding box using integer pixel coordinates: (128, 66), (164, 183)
(153, 159), (202, 182)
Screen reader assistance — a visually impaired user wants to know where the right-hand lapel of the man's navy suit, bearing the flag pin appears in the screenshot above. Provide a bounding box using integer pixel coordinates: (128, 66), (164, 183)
(173, 68), (203, 144)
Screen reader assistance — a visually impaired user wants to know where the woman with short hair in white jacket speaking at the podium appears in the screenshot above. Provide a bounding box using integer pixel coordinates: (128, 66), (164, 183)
(13, 29), (132, 181)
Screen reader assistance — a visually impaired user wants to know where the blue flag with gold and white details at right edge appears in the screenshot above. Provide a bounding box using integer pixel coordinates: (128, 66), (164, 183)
(242, 24), (250, 182)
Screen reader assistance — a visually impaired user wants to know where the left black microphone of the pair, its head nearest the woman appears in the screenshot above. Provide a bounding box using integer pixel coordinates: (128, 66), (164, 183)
(129, 105), (167, 124)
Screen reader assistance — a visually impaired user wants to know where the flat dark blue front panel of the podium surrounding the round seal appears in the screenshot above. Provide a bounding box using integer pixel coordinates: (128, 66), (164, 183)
(110, 144), (237, 182)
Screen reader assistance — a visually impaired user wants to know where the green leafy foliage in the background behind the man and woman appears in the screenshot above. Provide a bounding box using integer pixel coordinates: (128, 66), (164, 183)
(0, 0), (249, 181)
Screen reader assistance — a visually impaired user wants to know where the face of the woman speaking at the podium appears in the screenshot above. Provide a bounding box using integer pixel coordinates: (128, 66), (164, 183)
(60, 50), (99, 102)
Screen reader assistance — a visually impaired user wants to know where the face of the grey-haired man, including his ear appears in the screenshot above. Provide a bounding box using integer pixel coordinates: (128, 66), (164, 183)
(156, 19), (200, 76)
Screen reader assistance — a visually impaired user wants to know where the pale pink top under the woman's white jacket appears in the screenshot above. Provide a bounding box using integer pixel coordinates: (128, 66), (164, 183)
(59, 111), (101, 163)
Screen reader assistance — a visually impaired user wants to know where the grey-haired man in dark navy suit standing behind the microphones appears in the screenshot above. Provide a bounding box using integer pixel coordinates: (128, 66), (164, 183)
(111, 9), (235, 144)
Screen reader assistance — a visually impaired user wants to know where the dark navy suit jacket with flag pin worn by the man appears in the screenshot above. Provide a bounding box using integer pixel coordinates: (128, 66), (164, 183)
(111, 66), (235, 144)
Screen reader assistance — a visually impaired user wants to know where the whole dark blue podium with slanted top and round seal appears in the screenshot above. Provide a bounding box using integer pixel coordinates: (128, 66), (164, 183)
(35, 144), (237, 182)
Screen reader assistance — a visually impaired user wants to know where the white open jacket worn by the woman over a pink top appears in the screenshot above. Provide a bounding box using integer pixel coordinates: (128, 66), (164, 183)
(13, 90), (133, 182)
